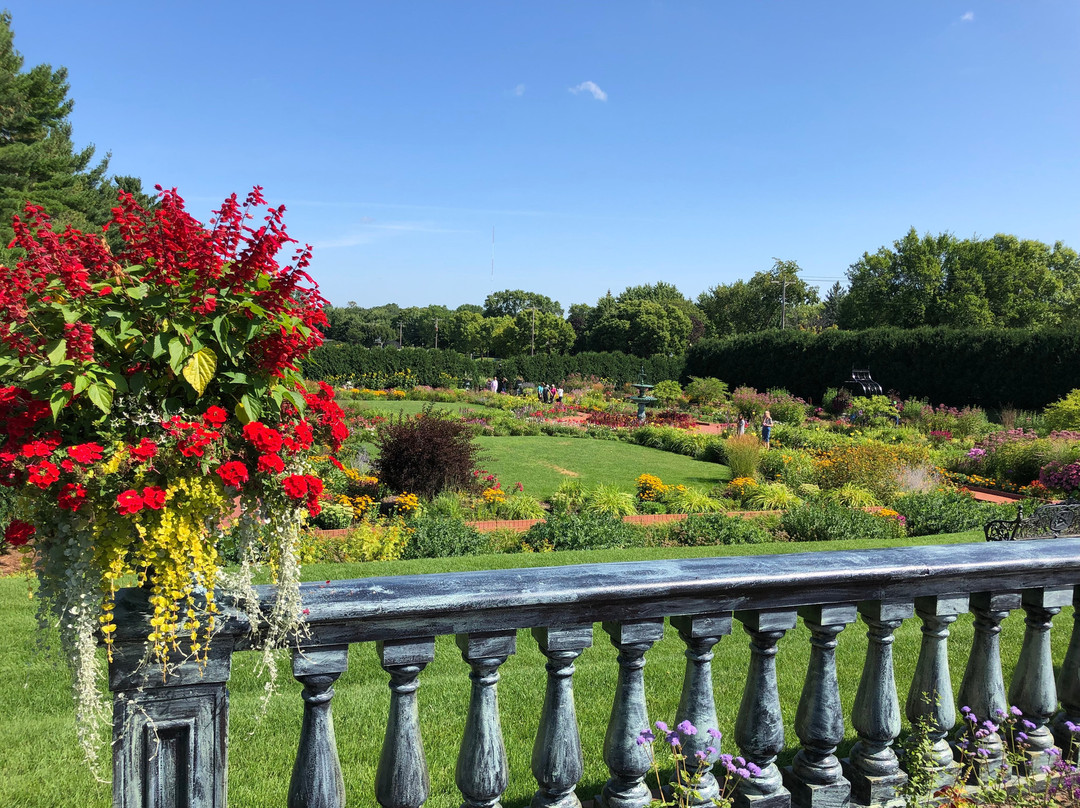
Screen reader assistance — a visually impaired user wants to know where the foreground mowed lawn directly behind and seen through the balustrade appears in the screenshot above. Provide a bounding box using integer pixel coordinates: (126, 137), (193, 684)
(0, 531), (1072, 808)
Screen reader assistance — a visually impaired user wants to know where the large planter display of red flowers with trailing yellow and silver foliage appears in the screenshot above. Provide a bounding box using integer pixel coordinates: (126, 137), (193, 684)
(0, 188), (348, 759)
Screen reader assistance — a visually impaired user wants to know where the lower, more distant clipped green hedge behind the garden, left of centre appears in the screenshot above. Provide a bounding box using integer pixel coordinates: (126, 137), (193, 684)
(303, 342), (686, 387)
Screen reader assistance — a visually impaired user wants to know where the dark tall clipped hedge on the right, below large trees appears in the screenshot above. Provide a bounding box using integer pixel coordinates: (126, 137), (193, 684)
(685, 327), (1080, 409)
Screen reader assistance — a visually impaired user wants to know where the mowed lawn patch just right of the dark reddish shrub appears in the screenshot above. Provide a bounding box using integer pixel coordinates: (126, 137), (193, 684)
(476, 435), (731, 499)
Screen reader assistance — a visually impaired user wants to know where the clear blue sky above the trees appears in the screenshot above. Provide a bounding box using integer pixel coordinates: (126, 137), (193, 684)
(6, 0), (1080, 308)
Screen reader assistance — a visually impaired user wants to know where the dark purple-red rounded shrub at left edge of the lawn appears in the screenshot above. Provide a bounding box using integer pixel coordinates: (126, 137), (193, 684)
(374, 406), (480, 499)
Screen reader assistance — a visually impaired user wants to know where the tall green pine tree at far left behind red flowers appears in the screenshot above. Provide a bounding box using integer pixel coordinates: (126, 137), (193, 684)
(0, 12), (126, 259)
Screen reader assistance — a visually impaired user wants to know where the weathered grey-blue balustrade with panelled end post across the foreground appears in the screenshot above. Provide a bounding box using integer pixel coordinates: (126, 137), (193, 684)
(110, 538), (1080, 808)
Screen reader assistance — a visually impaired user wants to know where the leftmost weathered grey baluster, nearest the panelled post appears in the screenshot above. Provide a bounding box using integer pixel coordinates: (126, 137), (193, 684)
(286, 645), (349, 808)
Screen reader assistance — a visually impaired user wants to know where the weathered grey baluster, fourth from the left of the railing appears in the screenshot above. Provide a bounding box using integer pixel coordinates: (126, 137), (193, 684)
(531, 624), (593, 808)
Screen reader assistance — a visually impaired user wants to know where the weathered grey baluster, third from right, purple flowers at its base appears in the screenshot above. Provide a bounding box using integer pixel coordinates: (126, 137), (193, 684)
(956, 592), (1020, 782)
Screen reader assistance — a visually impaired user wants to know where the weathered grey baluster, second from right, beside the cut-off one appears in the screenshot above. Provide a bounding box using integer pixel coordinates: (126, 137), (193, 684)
(1007, 587), (1072, 775)
